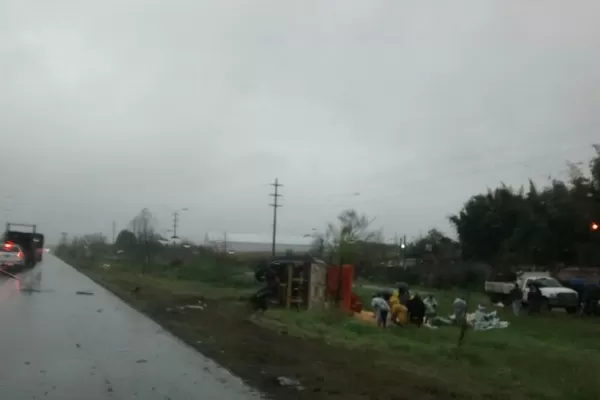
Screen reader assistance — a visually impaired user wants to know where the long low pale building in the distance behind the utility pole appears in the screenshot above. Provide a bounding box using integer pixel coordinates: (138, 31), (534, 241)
(204, 233), (314, 253)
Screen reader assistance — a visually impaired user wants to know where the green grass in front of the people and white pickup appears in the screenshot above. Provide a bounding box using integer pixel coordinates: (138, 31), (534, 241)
(270, 287), (600, 400)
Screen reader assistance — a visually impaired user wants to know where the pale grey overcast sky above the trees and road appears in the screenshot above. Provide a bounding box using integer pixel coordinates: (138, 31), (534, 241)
(0, 0), (600, 241)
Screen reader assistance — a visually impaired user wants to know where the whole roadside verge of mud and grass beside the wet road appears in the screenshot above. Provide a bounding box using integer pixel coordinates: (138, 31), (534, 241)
(69, 262), (600, 400)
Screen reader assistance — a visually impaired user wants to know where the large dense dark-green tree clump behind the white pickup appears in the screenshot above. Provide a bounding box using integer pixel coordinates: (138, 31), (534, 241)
(450, 146), (600, 268)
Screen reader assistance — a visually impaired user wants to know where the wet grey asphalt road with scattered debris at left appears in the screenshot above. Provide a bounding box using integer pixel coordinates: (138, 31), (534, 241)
(0, 255), (259, 400)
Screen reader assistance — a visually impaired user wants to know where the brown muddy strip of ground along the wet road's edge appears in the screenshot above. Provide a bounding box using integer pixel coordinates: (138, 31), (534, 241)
(81, 273), (455, 400)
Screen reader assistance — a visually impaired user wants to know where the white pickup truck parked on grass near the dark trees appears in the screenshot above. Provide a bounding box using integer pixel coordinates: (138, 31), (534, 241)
(485, 272), (579, 314)
